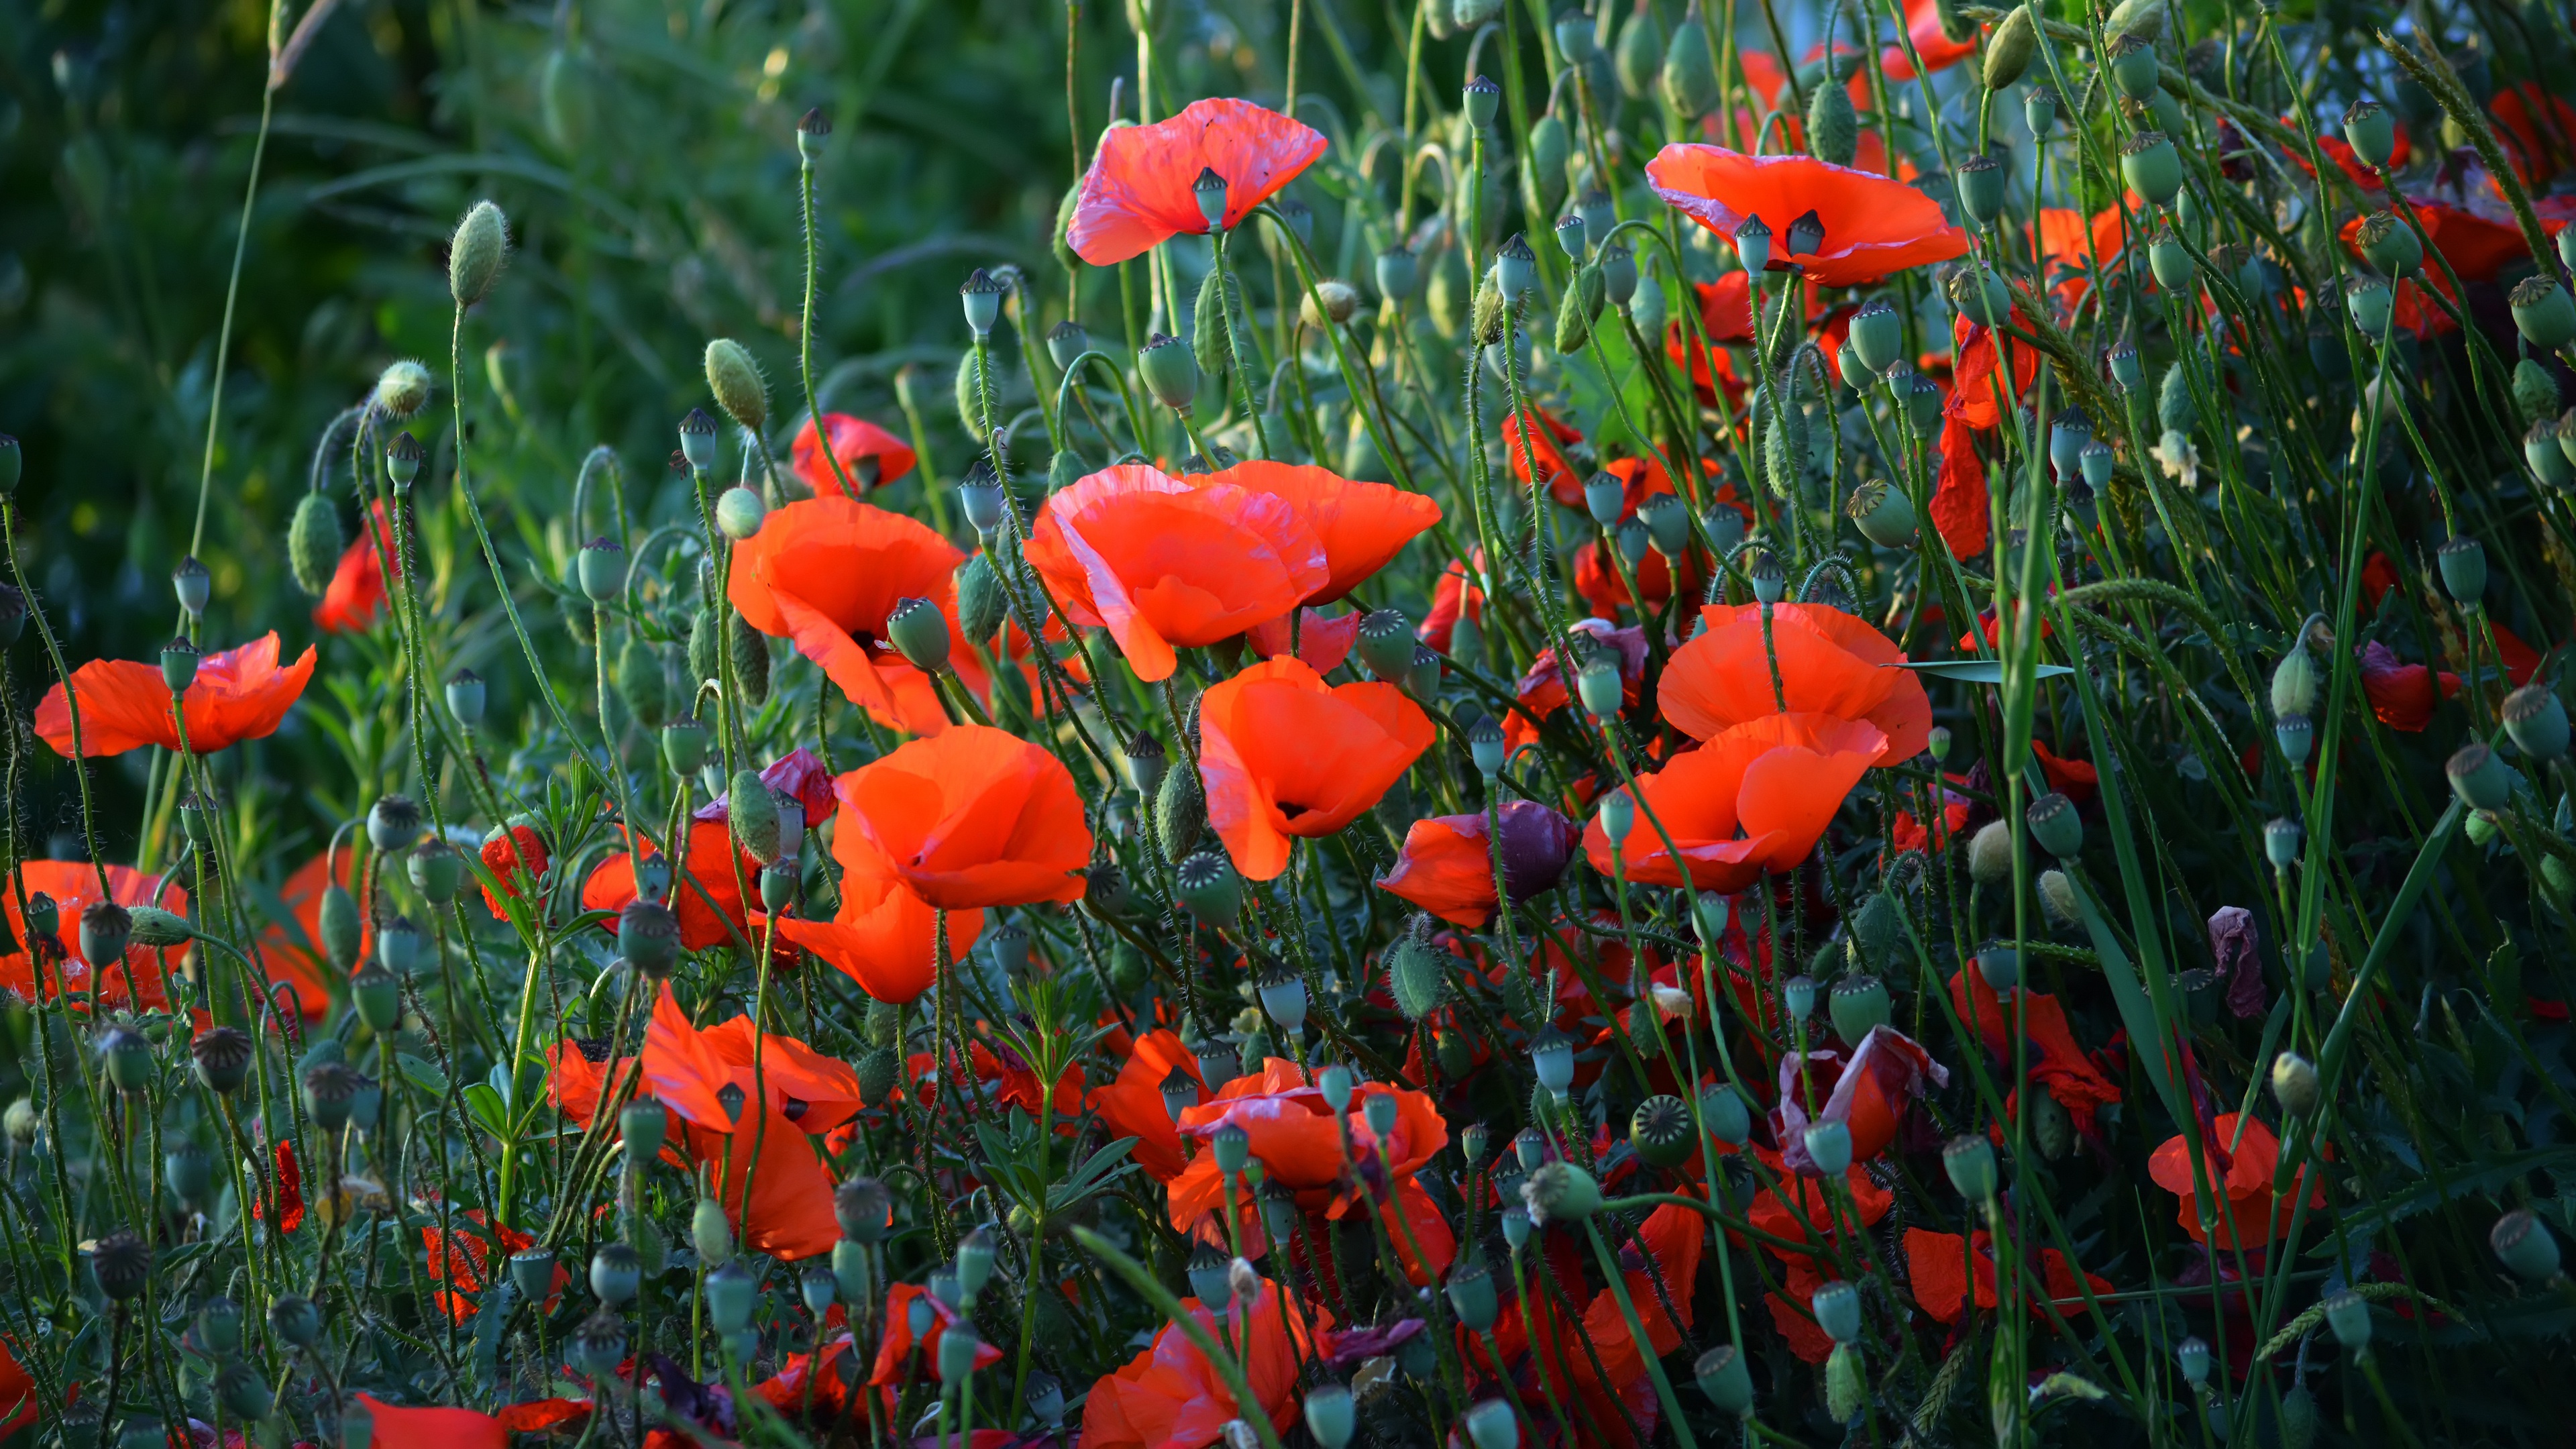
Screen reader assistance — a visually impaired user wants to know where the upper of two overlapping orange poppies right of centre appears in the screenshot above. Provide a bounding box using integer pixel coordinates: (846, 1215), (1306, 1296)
(1656, 603), (1932, 765)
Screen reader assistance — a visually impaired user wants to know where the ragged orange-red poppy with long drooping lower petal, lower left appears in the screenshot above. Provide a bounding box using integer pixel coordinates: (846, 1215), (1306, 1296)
(636, 985), (861, 1258)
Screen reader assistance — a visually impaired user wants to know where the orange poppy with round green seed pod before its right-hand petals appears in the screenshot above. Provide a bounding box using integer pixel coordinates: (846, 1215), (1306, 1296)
(727, 492), (981, 735)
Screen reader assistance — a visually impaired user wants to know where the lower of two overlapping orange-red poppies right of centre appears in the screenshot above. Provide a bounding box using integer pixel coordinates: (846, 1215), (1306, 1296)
(1585, 711), (1888, 895)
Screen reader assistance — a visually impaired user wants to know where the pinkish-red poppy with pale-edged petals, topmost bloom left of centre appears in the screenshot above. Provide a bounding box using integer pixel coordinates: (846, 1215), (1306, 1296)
(1064, 98), (1324, 266)
